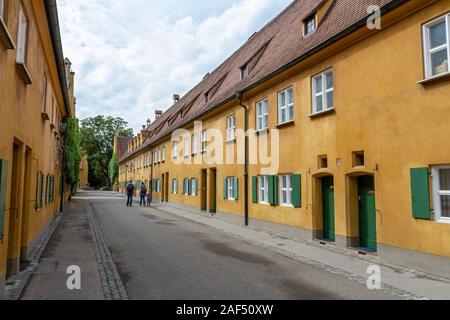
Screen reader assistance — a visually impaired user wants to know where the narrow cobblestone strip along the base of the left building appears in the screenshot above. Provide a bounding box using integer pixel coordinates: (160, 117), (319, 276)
(0, 213), (64, 300)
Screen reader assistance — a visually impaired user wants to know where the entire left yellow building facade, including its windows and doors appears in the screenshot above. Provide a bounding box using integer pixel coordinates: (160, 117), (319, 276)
(0, 0), (70, 291)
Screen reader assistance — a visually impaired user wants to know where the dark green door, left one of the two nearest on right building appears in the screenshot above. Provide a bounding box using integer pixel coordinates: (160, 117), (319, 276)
(322, 176), (336, 241)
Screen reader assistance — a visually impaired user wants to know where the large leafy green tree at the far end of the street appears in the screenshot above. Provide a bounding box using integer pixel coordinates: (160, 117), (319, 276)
(80, 116), (133, 186)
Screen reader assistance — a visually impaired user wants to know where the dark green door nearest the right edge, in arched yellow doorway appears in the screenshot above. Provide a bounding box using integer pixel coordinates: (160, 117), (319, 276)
(358, 176), (377, 251)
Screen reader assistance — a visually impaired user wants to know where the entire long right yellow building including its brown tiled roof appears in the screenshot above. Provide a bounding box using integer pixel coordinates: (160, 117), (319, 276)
(119, 0), (450, 276)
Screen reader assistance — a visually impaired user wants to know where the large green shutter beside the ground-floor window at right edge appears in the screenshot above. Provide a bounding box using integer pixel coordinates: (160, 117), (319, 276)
(411, 168), (431, 219)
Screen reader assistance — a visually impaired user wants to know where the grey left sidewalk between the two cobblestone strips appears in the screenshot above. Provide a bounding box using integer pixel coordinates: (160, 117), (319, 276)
(22, 200), (104, 300)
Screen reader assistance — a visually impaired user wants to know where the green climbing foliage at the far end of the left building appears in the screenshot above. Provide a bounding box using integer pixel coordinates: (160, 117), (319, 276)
(64, 118), (82, 191)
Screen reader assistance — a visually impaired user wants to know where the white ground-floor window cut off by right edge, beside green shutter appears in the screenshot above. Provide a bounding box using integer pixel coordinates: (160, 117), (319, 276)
(433, 165), (450, 222)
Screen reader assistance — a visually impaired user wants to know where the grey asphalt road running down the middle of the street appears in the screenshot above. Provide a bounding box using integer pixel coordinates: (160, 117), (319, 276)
(85, 193), (395, 300)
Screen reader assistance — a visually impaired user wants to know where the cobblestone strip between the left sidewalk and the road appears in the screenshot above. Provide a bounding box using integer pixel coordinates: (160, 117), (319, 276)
(86, 202), (128, 300)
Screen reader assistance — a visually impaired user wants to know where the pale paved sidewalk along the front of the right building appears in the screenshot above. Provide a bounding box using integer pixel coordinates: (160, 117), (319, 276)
(153, 203), (450, 300)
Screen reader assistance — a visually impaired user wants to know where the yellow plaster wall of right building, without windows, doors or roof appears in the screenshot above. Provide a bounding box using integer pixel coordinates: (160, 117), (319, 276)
(121, 1), (450, 264)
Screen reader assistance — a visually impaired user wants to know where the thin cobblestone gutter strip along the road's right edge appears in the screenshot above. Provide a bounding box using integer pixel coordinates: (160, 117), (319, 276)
(156, 207), (429, 300)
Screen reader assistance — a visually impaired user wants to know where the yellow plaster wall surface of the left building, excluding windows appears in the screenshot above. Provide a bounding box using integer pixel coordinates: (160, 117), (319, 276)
(0, 1), (64, 282)
